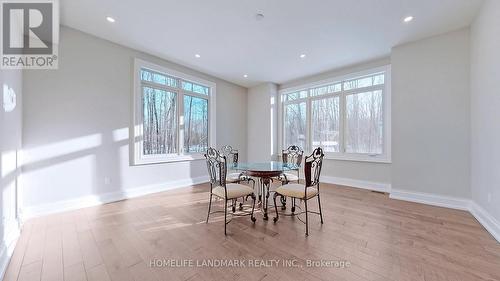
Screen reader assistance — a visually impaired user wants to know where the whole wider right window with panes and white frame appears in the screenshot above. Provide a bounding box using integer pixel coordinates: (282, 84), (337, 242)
(280, 66), (390, 162)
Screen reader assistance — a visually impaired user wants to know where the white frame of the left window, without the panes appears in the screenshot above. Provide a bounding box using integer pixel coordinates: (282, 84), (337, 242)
(130, 58), (217, 165)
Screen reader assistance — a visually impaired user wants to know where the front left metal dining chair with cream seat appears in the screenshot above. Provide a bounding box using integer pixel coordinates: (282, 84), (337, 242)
(205, 148), (256, 235)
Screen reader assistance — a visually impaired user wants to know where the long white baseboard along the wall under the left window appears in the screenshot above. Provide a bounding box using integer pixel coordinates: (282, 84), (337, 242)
(20, 176), (208, 221)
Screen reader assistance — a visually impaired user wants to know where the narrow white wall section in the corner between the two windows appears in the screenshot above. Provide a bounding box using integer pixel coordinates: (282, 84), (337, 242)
(247, 83), (278, 162)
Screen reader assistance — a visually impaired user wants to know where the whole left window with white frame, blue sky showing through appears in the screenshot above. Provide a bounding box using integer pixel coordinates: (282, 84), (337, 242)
(131, 60), (215, 164)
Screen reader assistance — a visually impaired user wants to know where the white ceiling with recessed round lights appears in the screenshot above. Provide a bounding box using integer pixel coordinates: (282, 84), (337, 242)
(61, 0), (482, 87)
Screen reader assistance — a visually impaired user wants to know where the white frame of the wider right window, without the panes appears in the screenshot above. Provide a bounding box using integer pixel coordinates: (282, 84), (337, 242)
(278, 65), (392, 163)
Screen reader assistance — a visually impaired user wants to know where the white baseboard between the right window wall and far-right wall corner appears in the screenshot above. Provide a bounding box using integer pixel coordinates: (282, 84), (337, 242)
(389, 189), (470, 211)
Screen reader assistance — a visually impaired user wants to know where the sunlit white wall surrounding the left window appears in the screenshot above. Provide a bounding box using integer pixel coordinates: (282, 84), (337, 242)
(22, 27), (247, 216)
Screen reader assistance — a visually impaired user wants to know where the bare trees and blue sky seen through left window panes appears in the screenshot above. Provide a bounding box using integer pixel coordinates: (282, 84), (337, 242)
(139, 65), (211, 163)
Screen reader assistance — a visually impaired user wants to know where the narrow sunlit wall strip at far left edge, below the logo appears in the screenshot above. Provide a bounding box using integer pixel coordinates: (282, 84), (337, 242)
(0, 70), (22, 279)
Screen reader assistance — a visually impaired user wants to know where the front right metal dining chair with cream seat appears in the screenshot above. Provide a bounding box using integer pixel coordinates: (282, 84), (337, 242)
(273, 147), (324, 236)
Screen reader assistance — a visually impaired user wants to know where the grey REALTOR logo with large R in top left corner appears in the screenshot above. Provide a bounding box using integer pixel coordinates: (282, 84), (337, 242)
(1, 0), (59, 69)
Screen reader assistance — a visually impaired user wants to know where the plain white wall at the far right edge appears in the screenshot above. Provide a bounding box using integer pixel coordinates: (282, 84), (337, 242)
(470, 0), (500, 221)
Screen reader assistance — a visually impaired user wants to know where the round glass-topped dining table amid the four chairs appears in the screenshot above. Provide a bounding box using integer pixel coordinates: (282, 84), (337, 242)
(232, 161), (299, 220)
